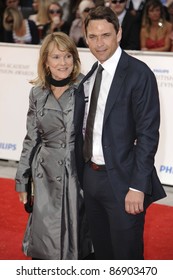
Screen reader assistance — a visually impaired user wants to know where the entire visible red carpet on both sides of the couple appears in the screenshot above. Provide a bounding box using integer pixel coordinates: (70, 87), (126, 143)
(0, 178), (173, 260)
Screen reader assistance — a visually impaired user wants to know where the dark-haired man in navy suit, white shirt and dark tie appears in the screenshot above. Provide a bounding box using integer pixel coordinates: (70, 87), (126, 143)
(74, 6), (165, 260)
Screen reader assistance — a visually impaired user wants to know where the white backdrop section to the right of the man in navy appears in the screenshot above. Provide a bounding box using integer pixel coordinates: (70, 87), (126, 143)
(129, 52), (173, 185)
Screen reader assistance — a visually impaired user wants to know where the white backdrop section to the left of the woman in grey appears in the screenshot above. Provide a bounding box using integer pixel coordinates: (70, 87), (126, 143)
(0, 44), (38, 160)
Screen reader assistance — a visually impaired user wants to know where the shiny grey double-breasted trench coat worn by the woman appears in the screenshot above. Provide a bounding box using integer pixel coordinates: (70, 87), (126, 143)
(16, 79), (92, 260)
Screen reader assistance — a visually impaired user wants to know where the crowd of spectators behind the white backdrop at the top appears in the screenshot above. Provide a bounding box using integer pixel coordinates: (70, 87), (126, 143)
(0, 0), (173, 52)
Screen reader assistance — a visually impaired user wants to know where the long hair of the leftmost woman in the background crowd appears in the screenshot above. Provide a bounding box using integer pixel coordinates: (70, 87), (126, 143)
(3, 7), (23, 31)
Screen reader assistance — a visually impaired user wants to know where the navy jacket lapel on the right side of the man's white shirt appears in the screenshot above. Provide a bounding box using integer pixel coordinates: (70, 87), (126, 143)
(103, 51), (128, 124)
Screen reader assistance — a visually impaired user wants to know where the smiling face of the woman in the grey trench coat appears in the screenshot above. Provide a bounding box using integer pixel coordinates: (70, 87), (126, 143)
(46, 45), (74, 81)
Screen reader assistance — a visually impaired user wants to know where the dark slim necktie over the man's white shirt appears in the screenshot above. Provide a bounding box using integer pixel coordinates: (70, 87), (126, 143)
(84, 64), (103, 162)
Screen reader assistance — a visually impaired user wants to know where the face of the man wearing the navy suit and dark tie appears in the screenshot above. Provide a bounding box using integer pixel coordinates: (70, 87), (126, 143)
(86, 19), (121, 63)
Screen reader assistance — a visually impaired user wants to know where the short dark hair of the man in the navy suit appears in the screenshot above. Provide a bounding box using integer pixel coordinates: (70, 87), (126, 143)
(84, 6), (120, 34)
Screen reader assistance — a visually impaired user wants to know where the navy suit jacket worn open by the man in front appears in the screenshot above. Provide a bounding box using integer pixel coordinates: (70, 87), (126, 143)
(74, 51), (166, 207)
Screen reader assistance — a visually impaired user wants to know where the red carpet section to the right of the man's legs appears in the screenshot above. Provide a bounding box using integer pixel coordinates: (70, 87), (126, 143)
(144, 204), (173, 260)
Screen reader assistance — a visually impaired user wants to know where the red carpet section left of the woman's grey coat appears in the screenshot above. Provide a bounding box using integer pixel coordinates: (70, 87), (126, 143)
(0, 178), (29, 260)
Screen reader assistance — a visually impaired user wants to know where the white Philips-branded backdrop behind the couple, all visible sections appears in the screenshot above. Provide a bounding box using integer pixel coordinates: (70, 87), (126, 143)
(0, 43), (173, 186)
